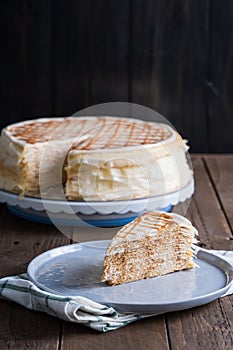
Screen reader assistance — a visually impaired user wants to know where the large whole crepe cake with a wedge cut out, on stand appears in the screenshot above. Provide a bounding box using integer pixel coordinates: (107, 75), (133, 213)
(0, 116), (192, 201)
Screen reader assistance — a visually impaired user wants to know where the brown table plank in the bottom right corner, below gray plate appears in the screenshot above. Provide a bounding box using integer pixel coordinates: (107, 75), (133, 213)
(167, 297), (233, 350)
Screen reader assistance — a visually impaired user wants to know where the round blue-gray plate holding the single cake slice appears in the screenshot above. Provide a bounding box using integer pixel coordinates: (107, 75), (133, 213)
(27, 241), (233, 313)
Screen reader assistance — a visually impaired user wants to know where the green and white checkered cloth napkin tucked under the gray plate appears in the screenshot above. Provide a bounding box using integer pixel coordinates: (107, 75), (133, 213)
(0, 250), (233, 332)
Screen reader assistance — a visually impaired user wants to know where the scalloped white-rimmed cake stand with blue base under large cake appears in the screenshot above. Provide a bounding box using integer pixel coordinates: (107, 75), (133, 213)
(0, 179), (194, 227)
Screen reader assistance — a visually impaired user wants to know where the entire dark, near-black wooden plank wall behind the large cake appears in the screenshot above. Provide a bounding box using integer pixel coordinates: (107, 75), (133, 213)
(0, 0), (233, 153)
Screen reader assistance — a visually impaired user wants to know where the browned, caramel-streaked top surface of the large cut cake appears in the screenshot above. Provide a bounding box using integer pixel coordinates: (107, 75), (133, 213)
(7, 117), (172, 150)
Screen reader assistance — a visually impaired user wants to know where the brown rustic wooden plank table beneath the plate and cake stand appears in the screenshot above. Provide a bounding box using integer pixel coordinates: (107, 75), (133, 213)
(0, 155), (233, 350)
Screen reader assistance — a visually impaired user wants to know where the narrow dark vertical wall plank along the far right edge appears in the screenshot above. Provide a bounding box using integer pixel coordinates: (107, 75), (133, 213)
(208, 0), (233, 152)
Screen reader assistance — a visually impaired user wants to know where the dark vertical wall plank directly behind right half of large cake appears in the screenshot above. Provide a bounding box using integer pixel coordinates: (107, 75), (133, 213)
(131, 0), (209, 152)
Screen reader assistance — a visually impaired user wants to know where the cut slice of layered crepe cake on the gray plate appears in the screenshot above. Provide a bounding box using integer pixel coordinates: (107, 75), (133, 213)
(102, 211), (197, 285)
